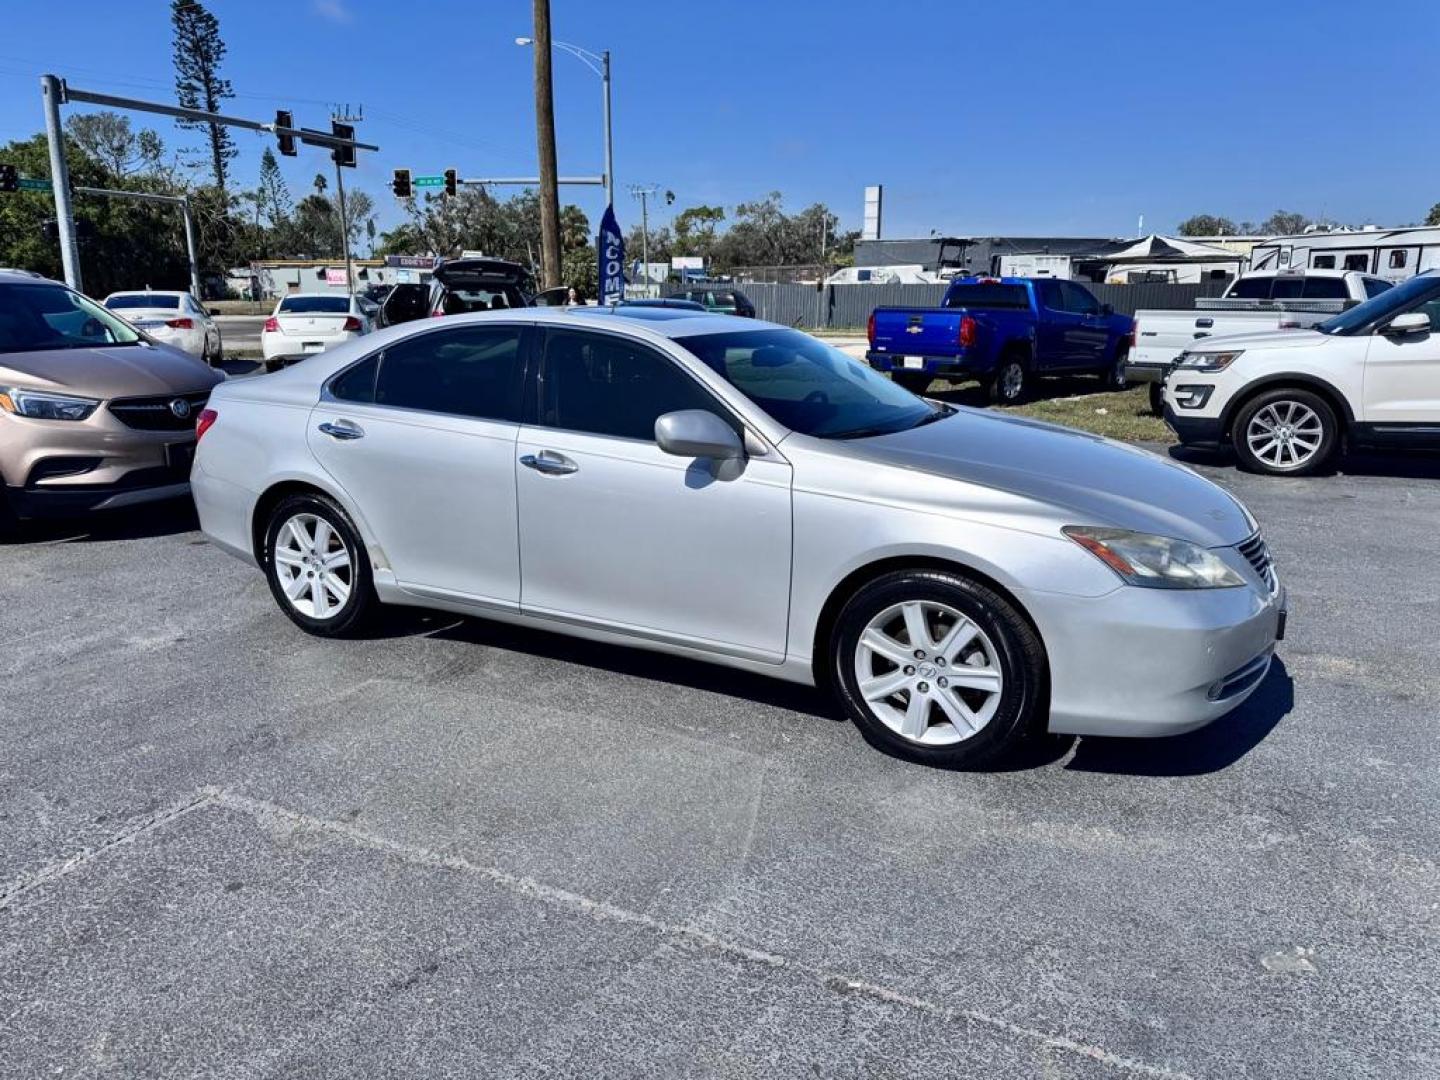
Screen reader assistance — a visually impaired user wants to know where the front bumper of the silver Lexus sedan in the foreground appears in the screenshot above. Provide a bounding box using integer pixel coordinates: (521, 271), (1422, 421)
(1022, 586), (1286, 736)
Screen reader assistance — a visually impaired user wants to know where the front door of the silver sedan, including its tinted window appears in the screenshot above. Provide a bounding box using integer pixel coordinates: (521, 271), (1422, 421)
(516, 330), (791, 661)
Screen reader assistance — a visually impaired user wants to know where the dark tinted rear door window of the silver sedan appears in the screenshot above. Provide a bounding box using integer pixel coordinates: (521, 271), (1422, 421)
(374, 327), (524, 420)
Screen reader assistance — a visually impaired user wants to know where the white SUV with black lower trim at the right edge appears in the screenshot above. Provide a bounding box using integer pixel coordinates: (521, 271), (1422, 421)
(1165, 272), (1440, 477)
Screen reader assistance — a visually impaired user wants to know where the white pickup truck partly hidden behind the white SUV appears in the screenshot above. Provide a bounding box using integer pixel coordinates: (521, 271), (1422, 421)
(1125, 269), (1394, 413)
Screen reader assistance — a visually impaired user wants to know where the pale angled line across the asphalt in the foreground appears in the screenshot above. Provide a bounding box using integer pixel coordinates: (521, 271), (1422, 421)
(0, 788), (1194, 1080)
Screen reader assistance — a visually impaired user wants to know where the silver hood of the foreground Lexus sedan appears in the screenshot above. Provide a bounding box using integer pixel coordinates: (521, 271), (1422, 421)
(844, 409), (1254, 547)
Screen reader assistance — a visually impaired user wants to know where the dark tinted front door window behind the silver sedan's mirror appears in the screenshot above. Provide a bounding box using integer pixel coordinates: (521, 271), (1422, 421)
(540, 330), (730, 442)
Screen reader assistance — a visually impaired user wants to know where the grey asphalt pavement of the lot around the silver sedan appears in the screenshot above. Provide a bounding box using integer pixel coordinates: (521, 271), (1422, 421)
(0, 443), (1440, 1080)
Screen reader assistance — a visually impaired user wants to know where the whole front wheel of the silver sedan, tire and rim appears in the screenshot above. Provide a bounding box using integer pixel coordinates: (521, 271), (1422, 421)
(829, 570), (1047, 769)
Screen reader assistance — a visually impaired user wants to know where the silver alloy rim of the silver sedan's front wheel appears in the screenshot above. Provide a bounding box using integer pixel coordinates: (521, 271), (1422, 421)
(854, 600), (1005, 746)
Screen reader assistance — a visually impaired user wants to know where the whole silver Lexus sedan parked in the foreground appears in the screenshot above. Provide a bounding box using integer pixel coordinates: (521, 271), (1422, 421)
(192, 307), (1284, 766)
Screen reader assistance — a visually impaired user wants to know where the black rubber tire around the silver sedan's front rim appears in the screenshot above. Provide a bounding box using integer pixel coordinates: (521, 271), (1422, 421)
(827, 570), (1050, 769)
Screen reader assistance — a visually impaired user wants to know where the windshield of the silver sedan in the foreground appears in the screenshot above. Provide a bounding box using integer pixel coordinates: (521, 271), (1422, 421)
(675, 330), (948, 439)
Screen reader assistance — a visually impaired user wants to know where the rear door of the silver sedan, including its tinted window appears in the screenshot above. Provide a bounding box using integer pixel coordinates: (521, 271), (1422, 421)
(310, 323), (534, 608)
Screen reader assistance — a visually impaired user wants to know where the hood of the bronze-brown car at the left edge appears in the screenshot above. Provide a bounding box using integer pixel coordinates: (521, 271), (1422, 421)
(0, 346), (223, 399)
